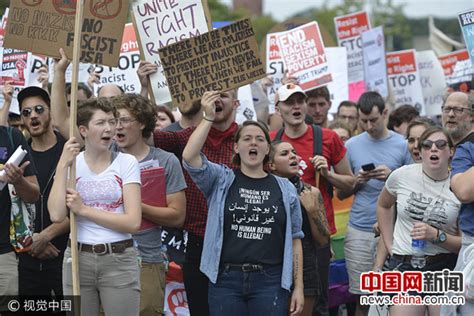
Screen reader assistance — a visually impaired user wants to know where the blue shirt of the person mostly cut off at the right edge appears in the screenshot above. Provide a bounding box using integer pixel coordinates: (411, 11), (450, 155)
(451, 142), (474, 236)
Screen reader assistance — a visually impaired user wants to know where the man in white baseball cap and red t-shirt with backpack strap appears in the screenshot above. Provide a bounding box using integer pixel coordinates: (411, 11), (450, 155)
(270, 83), (354, 315)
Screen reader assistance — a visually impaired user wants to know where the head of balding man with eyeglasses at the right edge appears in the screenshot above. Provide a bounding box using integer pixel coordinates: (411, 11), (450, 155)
(441, 92), (474, 146)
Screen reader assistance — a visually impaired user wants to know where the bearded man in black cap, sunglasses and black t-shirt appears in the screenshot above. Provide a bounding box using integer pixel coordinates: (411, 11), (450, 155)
(14, 87), (69, 296)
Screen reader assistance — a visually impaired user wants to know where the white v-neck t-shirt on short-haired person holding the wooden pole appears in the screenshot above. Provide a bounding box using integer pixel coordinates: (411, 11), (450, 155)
(76, 152), (140, 244)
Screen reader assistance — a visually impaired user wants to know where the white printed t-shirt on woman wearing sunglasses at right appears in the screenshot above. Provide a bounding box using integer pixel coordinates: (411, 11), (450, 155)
(385, 163), (461, 256)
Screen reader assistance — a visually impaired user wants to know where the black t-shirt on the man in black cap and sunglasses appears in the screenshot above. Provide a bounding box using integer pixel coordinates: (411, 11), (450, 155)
(19, 132), (69, 270)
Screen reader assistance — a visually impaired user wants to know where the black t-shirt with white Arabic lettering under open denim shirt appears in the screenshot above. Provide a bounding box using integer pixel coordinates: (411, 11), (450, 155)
(221, 170), (286, 265)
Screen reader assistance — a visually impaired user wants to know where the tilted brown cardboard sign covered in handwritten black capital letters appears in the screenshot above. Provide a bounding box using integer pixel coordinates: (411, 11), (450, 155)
(159, 19), (266, 106)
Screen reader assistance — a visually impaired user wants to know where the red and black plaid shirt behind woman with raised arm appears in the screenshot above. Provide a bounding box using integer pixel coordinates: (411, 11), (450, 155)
(153, 123), (236, 237)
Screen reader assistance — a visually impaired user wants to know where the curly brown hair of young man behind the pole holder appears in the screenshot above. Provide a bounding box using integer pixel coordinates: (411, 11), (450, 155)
(112, 93), (156, 138)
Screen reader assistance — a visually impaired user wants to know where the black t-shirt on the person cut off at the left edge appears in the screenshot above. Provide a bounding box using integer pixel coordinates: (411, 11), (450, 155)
(0, 126), (36, 254)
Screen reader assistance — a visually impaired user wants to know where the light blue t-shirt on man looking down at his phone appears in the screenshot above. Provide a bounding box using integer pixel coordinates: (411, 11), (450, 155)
(346, 131), (412, 232)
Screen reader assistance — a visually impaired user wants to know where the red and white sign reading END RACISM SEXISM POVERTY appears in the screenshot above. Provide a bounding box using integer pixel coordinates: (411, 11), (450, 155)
(277, 22), (332, 90)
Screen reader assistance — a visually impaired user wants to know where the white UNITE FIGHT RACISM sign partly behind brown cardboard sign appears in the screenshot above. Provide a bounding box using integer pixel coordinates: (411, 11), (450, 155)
(133, 0), (209, 104)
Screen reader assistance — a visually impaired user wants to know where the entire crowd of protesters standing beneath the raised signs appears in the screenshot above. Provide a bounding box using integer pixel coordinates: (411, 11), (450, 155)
(0, 43), (474, 316)
